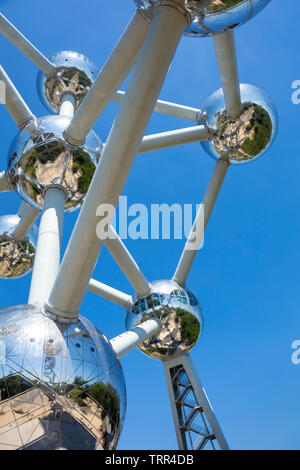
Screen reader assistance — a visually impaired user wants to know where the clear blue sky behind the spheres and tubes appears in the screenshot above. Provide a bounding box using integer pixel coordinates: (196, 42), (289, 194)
(0, 0), (300, 449)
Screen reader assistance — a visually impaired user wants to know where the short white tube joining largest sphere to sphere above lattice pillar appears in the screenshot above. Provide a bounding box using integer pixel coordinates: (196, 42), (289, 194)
(110, 318), (161, 357)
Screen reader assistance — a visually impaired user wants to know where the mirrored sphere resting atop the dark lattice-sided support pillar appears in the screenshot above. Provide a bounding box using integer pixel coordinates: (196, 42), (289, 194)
(126, 280), (203, 360)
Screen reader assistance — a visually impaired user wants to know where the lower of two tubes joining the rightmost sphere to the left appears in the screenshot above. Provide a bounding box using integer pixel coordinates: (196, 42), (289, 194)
(138, 126), (208, 153)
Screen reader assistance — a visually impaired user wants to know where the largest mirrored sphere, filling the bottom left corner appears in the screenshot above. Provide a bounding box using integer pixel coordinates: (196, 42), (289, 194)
(0, 305), (126, 450)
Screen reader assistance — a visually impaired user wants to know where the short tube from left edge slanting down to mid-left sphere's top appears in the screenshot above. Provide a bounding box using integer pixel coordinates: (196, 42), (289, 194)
(0, 65), (34, 129)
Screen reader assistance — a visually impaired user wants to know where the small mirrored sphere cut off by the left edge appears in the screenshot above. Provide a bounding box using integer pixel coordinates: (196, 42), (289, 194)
(0, 215), (37, 279)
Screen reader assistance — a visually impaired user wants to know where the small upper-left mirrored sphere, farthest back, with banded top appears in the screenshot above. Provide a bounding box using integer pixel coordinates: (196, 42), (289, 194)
(37, 51), (98, 113)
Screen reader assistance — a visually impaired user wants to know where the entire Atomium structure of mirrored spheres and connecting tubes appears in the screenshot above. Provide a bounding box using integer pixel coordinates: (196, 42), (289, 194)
(0, 0), (277, 450)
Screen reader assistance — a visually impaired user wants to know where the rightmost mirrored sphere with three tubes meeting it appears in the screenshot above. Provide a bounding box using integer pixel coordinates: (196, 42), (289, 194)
(201, 84), (278, 164)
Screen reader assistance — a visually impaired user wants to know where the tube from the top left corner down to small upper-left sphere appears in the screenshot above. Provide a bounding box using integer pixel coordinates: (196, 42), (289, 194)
(0, 13), (55, 75)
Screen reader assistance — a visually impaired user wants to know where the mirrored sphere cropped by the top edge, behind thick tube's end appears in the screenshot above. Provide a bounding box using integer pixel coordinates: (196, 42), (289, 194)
(134, 0), (271, 36)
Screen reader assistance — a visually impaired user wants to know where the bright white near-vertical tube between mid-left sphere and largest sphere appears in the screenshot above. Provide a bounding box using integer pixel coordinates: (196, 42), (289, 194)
(28, 187), (66, 306)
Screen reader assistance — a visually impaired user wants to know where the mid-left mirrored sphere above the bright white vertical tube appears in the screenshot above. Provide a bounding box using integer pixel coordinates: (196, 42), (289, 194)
(8, 115), (102, 211)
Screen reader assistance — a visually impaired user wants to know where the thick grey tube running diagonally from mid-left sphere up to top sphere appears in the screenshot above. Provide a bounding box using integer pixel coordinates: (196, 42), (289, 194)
(65, 10), (149, 145)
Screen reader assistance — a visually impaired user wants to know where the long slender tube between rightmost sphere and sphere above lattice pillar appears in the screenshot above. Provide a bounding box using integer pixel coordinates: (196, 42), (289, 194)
(173, 159), (229, 285)
